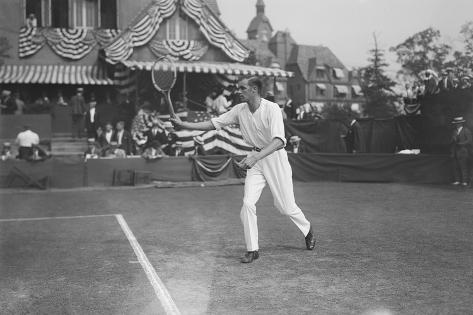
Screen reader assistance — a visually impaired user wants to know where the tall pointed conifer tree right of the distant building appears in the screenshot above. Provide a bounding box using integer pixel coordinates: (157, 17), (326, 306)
(360, 34), (397, 118)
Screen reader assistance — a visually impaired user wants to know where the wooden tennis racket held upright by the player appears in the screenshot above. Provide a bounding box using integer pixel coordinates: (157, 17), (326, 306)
(151, 56), (177, 117)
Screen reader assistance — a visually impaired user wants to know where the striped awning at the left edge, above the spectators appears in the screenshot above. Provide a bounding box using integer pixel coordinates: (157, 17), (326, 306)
(0, 65), (113, 85)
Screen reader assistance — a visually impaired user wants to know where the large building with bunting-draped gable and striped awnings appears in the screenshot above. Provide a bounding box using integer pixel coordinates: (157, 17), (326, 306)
(0, 0), (291, 122)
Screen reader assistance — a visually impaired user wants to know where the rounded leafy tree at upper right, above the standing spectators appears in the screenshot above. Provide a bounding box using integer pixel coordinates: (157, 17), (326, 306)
(390, 27), (452, 74)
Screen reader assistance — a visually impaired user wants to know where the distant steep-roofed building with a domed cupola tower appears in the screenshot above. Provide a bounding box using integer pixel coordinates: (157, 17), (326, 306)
(244, 0), (365, 110)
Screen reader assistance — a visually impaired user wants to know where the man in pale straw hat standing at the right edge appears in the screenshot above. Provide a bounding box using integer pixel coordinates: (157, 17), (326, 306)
(451, 117), (473, 186)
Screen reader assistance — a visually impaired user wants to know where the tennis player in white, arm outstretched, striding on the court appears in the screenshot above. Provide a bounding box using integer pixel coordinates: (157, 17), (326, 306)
(171, 77), (315, 263)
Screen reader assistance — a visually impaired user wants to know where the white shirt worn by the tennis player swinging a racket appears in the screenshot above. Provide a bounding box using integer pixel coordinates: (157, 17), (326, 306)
(212, 98), (286, 149)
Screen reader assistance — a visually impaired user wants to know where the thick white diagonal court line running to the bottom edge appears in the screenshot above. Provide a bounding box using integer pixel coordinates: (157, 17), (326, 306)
(115, 214), (181, 315)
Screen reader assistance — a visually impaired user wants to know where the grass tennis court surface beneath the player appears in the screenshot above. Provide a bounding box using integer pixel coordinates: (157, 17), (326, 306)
(0, 182), (473, 314)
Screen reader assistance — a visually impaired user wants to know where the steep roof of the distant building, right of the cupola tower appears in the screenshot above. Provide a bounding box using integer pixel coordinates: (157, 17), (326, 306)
(287, 45), (346, 80)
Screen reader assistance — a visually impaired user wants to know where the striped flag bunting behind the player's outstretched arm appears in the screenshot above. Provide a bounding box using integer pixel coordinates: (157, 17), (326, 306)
(176, 111), (253, 155)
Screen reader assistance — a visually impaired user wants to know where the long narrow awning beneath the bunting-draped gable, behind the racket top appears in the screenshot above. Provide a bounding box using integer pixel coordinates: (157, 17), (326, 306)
(122, 60), (294, 77)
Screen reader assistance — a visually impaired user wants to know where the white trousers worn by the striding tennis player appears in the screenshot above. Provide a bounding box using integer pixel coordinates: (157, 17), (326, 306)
(240, 150), (310, 251)
